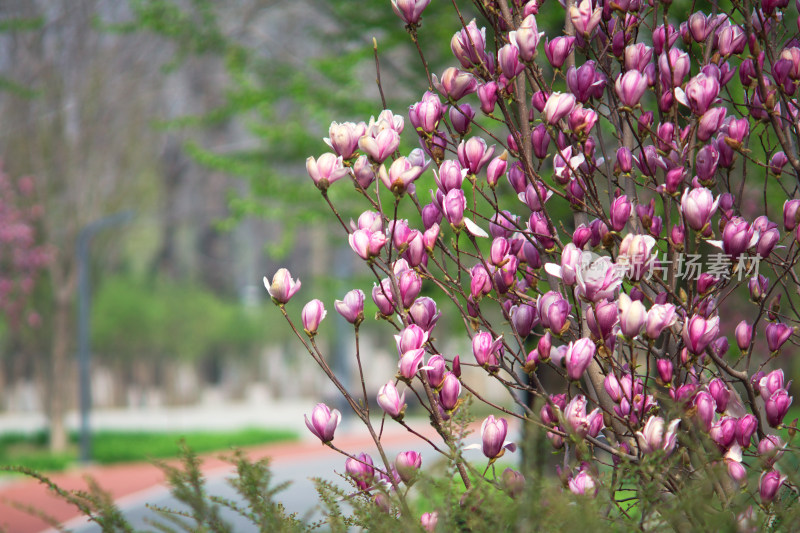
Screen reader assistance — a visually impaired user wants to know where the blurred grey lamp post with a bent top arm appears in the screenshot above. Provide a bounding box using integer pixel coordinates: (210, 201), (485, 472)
(75, 211), (133, 463)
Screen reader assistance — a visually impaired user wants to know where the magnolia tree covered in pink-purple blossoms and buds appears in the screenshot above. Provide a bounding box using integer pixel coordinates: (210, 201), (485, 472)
(265, 0), (800, 530)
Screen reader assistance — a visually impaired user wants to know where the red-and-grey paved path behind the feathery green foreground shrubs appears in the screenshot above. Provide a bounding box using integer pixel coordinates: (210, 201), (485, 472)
(0, 412), (462, 533)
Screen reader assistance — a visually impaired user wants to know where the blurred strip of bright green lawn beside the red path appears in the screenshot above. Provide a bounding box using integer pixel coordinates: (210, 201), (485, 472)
(0, 429), (298, 471)
